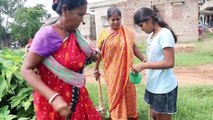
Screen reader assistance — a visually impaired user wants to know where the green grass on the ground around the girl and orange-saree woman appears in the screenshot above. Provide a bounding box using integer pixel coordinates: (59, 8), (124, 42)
(87, 34), (213, 120)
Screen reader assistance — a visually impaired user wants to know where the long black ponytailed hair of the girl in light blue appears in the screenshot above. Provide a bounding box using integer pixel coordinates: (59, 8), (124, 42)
(134, 7), (177, 43)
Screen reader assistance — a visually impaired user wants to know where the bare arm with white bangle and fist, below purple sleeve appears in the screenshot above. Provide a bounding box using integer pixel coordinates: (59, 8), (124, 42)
(21, 51), (71, 117)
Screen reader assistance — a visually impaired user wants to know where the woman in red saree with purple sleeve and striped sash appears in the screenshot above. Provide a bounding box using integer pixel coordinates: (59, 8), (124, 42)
(22, 0), (101, 120)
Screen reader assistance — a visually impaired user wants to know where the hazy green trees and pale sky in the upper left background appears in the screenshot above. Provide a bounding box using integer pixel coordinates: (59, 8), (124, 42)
(0, 0), (51, 49)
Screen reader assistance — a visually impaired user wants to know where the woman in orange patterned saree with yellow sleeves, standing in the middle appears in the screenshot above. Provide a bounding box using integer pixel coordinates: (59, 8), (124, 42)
(94, 7), (145, 120)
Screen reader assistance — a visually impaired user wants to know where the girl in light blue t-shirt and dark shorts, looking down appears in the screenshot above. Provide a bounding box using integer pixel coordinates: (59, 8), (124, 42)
(131, 7), (178, 120)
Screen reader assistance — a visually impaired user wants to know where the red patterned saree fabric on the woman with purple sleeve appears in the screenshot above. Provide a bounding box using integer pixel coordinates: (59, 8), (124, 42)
(34, 34), (101, 120)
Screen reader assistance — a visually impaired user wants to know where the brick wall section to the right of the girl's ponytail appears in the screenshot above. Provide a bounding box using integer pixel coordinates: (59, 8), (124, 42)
(153, 0), (198, 42)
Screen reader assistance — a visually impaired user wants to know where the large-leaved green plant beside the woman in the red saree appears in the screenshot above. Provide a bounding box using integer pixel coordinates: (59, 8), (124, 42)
(0, 49), (34, 120)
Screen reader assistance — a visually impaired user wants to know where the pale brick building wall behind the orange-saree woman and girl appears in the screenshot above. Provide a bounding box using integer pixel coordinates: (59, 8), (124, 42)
(91, 0), (198, 42)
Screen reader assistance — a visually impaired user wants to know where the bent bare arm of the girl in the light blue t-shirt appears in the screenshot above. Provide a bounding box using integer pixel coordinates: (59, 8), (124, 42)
(132, 47), (174, 72)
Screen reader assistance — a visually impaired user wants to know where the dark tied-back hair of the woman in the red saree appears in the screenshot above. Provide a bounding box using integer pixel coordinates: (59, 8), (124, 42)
(52, 0), (87, 15)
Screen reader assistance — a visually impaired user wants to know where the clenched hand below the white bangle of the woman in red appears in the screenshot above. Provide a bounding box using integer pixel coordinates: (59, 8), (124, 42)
(52, 96), (71, 117)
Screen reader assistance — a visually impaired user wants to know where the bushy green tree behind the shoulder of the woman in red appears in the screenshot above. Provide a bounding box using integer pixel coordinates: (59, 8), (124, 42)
(11, 4), (51, 44)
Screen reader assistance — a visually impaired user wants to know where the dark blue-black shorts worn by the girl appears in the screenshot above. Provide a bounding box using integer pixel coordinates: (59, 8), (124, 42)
(144, 87), (178, 114)
